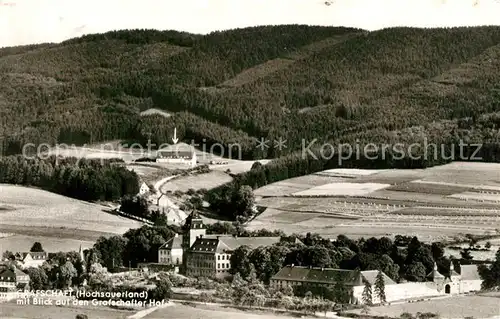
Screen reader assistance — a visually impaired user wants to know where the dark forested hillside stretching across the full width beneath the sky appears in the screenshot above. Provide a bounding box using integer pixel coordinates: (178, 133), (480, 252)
(0, 25), (500, 165)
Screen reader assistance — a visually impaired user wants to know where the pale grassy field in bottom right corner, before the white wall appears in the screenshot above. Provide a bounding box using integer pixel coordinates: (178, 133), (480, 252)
(352, 295), (500, 319)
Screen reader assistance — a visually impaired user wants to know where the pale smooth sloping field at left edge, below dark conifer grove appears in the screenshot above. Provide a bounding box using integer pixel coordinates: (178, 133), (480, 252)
(0, 184), (141, 250)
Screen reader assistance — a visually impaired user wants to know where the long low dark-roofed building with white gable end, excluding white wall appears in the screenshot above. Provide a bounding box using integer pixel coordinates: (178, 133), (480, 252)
(270, 264), (396, 304)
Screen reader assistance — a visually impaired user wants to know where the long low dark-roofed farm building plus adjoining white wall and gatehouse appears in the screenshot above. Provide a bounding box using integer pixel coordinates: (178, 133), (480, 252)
(271, 263), (482, 304)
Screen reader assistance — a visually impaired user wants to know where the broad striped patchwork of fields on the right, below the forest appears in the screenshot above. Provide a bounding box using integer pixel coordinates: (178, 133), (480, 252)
(247, 163), (500, 241)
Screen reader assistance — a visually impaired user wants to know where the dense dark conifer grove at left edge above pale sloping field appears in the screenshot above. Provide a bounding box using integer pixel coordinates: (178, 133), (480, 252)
(0, 155), (139, 201)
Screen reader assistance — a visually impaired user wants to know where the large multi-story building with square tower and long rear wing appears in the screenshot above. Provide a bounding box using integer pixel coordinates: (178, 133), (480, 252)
(158, 212), (281, 278)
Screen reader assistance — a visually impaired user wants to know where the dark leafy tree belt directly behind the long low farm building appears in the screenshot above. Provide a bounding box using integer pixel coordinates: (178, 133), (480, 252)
(231, 234), (459, 292)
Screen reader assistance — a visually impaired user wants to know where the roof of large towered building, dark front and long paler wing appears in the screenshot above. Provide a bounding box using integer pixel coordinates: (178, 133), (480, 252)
(191, 235), (280, 253)
